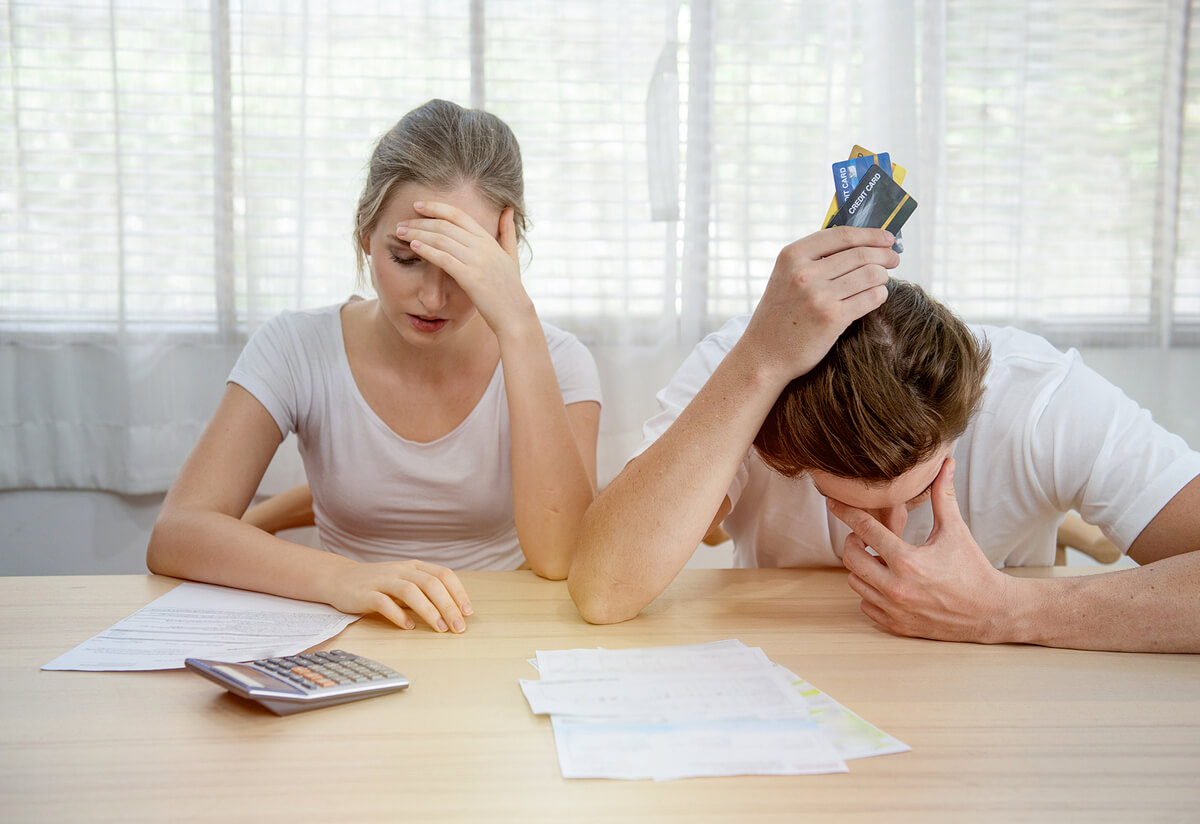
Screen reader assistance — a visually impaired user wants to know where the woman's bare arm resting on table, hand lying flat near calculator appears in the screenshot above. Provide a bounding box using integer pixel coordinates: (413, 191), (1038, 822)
(146, 384), (470, 631)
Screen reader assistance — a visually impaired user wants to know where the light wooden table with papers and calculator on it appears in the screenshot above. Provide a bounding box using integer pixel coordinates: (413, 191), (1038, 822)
(0, 570), (1200, 824)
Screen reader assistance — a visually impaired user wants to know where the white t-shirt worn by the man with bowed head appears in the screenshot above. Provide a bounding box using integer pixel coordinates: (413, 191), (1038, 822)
(637, 315), (1200, 567)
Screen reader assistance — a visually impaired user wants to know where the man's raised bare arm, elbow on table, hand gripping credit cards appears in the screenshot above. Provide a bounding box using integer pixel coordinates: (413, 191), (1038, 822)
(569, 227), (899, 624)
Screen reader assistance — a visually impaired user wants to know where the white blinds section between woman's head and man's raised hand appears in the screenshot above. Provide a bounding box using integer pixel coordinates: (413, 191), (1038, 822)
(484, 0), (673, 342)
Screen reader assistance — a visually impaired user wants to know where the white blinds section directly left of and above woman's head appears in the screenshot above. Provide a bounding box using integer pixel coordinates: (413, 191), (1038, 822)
(230, 0), (470, 327)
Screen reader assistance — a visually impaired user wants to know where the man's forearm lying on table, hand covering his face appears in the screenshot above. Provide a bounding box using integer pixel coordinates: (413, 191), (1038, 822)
(829, 461), (1200, 652)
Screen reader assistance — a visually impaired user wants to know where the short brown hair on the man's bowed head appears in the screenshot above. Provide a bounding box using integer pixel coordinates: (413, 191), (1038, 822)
(754, 278), (990, 483)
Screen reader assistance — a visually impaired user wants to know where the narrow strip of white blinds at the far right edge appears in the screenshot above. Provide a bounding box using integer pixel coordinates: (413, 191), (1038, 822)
(1172, 3), (1200, 344)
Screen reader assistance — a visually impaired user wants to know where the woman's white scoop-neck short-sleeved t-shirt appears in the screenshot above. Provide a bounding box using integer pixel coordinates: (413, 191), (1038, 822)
(229, 299), (600, 570)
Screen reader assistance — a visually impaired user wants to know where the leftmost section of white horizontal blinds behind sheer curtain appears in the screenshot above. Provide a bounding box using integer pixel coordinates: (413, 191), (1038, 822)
(0, 0), (214, 338)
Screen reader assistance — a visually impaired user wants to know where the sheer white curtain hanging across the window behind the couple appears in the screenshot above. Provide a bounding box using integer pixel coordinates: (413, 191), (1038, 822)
(0, 0), (1200, 493)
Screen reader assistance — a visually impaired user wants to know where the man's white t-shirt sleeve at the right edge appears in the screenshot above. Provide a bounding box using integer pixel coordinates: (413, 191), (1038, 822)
(1030, 350), (1200, 551)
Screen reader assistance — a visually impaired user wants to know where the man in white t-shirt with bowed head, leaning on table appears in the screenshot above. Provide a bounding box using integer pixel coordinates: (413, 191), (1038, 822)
(569, 227), (1200, 651)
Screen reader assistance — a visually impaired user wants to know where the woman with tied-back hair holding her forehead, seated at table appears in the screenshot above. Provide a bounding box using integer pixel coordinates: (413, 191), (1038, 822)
(146, 101), (600, 632)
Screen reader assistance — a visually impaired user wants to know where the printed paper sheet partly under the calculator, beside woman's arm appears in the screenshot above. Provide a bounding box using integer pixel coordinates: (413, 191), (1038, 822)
(42, 583), (359, 672)
